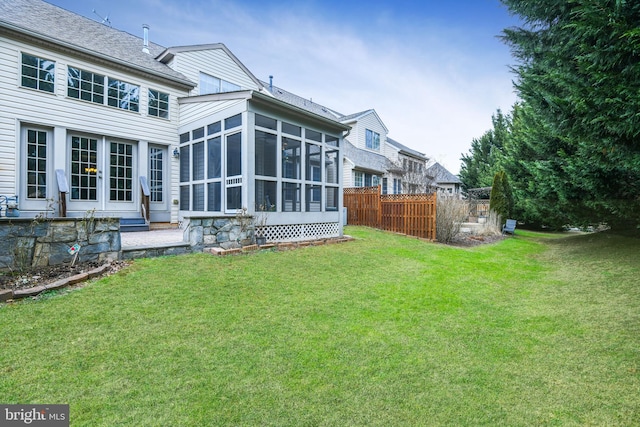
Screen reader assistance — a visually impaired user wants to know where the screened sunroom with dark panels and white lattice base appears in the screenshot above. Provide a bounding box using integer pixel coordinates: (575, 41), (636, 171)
(176, 90), (350, 242)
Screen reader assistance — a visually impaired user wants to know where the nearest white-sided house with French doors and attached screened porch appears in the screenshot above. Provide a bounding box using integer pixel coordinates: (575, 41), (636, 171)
(0, 0), (349, 240)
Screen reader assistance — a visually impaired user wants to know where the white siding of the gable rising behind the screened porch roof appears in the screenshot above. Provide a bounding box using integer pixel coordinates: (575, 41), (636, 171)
(174, 49), (259, 95)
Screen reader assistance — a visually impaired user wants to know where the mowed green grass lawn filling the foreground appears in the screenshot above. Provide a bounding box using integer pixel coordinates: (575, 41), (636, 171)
(0, 227), (640, 426)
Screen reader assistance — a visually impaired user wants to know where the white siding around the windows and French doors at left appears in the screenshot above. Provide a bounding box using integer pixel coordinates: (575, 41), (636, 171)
(0, 34), (188, 217)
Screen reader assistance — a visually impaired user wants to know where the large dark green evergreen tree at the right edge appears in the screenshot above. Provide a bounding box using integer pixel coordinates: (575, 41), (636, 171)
(502, 0), (640, 231)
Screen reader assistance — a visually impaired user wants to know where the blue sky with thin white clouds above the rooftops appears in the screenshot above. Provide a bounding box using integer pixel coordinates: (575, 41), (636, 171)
(48, 0), (517, 173)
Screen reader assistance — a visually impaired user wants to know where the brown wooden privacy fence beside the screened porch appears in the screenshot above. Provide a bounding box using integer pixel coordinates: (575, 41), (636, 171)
(344, 187), (436, 240)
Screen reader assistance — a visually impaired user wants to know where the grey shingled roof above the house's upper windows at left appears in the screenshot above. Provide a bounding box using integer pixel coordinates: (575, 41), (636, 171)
(0, 0), (195, 87)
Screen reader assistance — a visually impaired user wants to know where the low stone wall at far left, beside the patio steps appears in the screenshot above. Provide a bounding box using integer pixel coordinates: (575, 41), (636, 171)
(0, 218), (121, 269)
